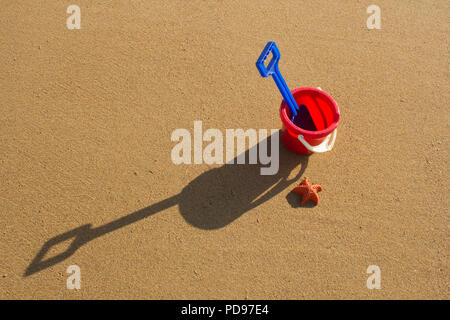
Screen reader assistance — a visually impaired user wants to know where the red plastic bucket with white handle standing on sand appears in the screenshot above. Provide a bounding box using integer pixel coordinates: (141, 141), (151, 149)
(280, 87), (340, 154)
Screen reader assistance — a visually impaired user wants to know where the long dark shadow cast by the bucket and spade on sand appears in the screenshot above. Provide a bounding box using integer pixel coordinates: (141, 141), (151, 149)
(24, 135), (308, 277)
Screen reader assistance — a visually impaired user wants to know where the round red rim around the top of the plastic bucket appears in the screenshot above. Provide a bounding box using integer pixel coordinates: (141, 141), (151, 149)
(280, 87), (341, 138)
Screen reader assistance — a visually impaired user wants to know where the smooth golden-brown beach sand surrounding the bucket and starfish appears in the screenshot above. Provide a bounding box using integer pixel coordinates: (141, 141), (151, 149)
(0, 0), (450, 299)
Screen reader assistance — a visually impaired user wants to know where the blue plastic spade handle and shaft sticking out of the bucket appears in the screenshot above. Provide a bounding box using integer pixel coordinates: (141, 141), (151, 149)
(256, 41), (299, 118)
